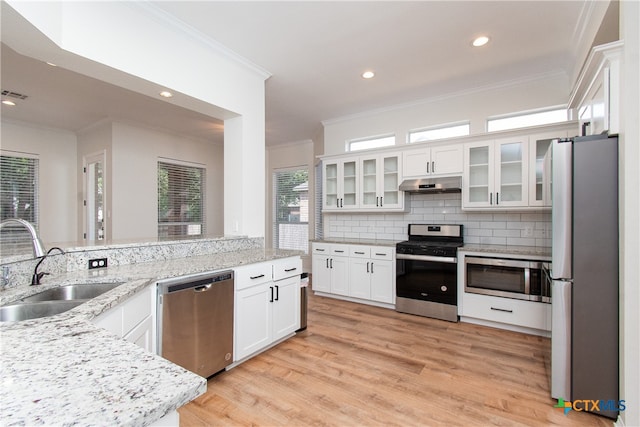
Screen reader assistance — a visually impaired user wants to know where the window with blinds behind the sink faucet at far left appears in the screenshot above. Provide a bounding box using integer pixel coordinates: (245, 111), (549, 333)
(0, 154), (38, 254)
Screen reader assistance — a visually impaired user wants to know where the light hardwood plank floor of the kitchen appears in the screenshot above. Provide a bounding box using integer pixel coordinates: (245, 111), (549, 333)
(179, 295), (612, 427)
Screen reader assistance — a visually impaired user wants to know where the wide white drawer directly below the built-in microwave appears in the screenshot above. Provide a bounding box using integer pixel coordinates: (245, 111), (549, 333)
(462, 292), (551, 331)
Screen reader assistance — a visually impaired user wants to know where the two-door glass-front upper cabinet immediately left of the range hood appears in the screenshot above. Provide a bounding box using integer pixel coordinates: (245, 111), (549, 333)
(359, 153), (405, 211)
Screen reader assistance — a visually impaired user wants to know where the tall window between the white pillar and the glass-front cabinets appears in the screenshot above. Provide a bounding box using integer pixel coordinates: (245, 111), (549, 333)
(273, 169), (309, 253)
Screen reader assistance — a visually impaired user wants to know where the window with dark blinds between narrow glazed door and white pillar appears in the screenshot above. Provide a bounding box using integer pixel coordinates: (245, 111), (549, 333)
(158, 161), (205, 239)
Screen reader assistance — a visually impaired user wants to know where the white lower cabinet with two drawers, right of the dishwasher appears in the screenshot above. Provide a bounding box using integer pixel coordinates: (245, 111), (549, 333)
(234, 257), (302, 362)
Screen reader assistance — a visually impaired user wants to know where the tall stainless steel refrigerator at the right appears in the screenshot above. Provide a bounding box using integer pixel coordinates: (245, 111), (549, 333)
(551, 135), (619, 419)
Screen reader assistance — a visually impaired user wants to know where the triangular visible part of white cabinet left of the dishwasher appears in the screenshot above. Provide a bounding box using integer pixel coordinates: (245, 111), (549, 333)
(93, 285), (156, 353)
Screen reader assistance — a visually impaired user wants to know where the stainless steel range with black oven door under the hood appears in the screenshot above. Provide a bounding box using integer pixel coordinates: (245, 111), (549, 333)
(396, 224), (463, 322)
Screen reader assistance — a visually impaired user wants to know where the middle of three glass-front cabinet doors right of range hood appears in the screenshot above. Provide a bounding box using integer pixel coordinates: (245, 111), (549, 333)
(493, 140), (529, 207)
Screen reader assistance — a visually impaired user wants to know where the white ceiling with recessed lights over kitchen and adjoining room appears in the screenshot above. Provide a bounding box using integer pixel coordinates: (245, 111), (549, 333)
(1, 0), (604, 145)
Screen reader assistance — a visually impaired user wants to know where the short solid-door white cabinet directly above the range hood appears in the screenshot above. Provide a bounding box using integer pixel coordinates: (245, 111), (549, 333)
(402, 144), (463, 178)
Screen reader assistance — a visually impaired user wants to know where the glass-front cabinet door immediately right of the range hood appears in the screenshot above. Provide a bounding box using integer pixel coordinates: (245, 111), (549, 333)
(463, 142), (494, 208)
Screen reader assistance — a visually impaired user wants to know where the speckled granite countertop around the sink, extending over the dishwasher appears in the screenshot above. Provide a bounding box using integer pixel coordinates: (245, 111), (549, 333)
(0, 249), (300, 426)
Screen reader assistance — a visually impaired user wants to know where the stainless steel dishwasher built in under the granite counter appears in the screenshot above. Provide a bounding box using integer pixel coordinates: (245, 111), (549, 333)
(157, 270), (234, 378)
